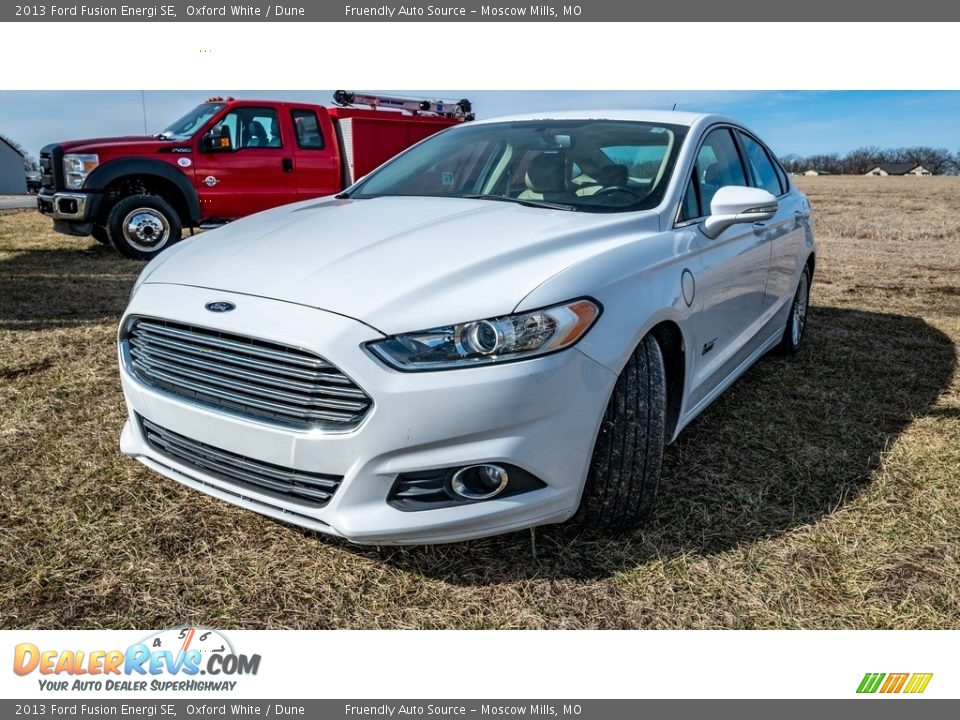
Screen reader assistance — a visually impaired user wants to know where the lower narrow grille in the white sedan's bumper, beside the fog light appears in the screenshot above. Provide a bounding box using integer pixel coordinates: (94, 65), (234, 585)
(140, 418), (343, 507)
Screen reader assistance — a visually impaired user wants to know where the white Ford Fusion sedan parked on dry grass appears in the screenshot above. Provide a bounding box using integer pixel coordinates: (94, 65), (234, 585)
(119, 111), (815, 544)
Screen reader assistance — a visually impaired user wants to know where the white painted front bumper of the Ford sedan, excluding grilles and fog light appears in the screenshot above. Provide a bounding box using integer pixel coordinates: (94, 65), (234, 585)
(120, 283), (616, 544)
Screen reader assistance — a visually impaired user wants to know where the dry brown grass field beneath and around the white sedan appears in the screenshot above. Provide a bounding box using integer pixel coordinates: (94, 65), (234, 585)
(0, 177), (960, 629)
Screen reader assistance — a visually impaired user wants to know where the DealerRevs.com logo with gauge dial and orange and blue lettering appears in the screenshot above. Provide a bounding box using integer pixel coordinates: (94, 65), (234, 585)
(13, 627), (260, 692)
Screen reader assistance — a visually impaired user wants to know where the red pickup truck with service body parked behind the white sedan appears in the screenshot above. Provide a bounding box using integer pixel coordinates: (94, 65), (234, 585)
(37, 90), (473, 260)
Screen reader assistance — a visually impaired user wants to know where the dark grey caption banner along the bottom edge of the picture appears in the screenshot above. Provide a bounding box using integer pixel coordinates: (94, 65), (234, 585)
(0, 696), (960, 720)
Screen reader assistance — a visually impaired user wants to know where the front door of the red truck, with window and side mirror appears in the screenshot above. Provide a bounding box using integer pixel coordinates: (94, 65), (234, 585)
(194, 106), (297, 220)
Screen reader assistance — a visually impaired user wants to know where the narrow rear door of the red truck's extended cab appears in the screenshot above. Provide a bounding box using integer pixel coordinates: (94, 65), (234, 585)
(290, 108), (343, 200)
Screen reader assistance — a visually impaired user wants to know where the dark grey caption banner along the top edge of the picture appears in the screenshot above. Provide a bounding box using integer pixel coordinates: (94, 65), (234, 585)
(7, 0), (960, 21)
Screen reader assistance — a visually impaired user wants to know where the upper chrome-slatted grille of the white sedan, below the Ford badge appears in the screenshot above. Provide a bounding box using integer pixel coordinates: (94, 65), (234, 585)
(124, 318), (372, 430)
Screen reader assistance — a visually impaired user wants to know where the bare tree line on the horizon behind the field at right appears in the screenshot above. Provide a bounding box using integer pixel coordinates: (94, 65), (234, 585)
(780, 145), (960, 175)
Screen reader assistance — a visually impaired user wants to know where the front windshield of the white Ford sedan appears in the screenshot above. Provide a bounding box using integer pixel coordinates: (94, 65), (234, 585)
(348, 120), (686, 212)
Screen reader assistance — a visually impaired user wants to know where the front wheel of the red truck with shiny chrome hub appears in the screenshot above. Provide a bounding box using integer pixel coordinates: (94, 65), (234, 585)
(107, 195), (183, 260)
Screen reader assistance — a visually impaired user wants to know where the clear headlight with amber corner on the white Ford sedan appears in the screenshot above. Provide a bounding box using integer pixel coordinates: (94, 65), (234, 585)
(368, 299), (600, 372)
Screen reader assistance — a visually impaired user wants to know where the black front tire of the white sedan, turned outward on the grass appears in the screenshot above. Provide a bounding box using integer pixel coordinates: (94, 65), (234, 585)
(574, 335), (667, 530)
